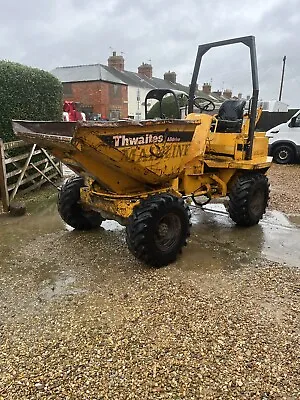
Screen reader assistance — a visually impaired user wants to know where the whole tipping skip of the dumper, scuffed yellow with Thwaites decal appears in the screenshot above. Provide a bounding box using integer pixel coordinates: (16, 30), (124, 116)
(13, 120), (199, 193)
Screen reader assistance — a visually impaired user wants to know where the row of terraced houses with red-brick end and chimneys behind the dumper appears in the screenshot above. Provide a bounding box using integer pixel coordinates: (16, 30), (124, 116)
(51, 52), (237, 120)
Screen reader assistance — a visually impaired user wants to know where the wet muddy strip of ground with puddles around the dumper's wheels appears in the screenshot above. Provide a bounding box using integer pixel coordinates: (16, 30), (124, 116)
(0, 198), (300, 314)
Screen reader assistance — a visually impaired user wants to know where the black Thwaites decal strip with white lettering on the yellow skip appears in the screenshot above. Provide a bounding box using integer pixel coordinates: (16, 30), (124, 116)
(101, 132), (193, 147)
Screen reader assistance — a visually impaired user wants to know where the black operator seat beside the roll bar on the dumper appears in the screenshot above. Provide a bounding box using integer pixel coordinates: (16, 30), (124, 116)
(217, 99), (246, 133)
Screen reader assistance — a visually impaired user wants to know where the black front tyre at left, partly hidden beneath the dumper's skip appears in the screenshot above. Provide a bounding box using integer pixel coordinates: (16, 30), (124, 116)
(57, 176), (104, 230)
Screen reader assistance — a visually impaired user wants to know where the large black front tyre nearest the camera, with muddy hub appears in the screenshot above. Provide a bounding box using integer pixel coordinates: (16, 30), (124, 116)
(126, 194), (191, 267)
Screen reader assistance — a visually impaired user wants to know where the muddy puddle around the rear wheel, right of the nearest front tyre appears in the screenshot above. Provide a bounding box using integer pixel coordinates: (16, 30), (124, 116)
(188, 204), (300, 268)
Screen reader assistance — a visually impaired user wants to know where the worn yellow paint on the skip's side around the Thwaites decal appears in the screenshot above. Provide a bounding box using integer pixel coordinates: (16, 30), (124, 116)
(72, 121), (197, 194)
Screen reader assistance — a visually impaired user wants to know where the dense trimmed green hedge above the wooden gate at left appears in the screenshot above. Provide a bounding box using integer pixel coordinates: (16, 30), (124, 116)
(0, 60), (62, 142)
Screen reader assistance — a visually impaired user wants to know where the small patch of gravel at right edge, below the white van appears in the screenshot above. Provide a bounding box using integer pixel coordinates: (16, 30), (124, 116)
(268, 164), (300, 214)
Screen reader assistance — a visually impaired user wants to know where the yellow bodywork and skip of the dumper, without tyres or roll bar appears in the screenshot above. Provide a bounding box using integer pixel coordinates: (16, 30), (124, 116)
(12, 111), (271, 222)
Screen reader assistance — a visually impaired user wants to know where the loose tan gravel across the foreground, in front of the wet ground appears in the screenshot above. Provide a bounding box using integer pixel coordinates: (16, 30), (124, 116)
(0, 263), (300, 400)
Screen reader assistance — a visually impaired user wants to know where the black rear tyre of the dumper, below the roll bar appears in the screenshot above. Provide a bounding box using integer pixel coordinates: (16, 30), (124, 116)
(228, 173), (270, 226)
